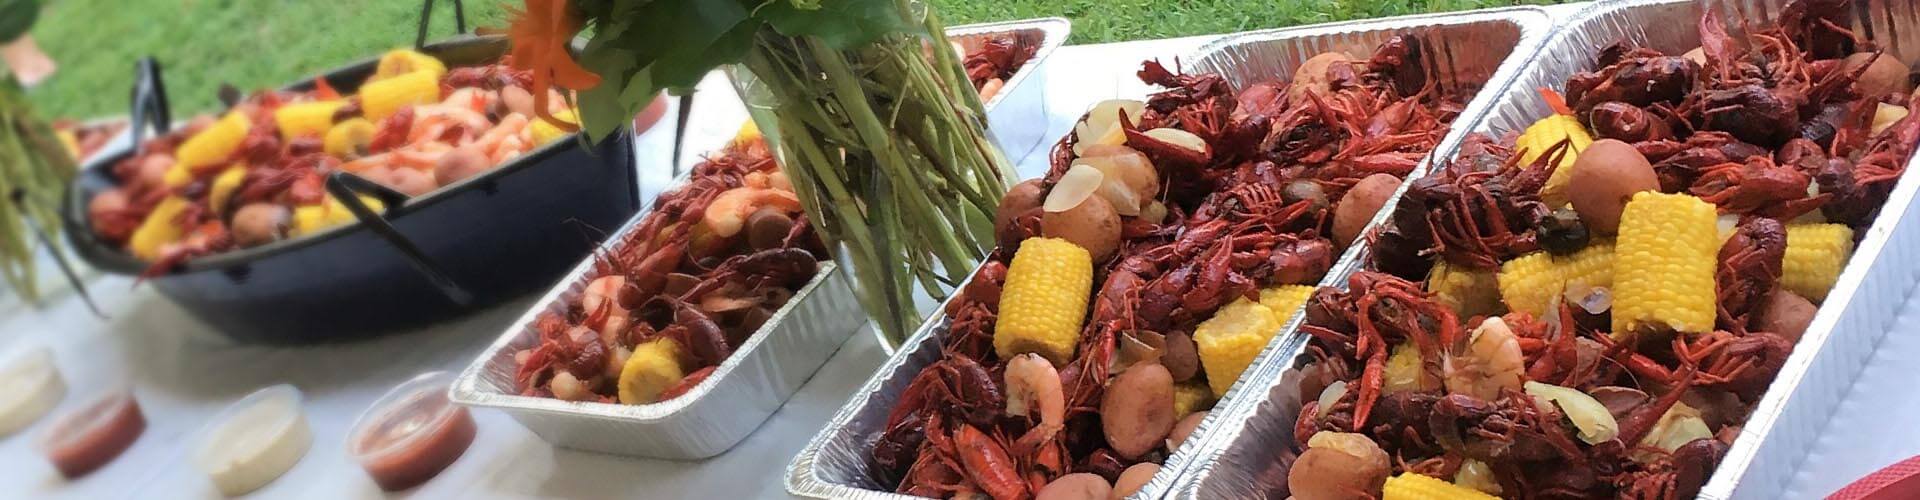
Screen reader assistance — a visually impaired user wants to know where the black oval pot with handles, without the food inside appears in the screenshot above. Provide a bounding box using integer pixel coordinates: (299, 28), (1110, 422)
(63, 37), (639, 344)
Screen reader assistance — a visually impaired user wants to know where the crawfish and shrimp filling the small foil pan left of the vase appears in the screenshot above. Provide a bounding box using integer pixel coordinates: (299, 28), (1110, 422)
(515, 127), (828, 404)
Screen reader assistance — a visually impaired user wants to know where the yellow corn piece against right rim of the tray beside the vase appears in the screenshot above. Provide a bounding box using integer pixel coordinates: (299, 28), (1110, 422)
(1194, 298), (1286, 398)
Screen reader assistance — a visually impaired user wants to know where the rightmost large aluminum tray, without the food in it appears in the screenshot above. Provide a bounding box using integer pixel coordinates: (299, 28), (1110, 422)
(1175, 0), (1920, 500)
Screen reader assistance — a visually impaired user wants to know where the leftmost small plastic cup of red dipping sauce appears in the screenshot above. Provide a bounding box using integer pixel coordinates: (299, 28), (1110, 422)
(40, 388), (146, 479)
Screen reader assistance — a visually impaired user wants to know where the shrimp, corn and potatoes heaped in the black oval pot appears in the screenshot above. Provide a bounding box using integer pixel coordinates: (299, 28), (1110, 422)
(86, 50), (574, 273)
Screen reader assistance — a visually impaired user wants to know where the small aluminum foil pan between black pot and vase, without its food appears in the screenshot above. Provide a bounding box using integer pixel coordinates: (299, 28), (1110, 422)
(449, 177), (866, 460)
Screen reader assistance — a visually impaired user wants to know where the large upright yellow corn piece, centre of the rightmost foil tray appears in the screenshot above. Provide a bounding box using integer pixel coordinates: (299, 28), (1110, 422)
(1613, 190), (1720, 337)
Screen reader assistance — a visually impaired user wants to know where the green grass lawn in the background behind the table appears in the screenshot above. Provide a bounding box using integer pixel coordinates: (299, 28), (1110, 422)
(29, 0), (1551, 117)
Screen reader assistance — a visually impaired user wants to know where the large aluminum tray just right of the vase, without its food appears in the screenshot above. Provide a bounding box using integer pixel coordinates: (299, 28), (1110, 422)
(787, 8), (1551, 498)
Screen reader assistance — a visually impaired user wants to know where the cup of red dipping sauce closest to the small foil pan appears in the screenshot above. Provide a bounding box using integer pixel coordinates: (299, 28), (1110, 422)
(348, 371), (476, 490)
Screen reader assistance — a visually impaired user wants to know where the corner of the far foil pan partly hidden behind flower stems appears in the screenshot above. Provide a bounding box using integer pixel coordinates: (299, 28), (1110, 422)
(947, 17), (1071, 158)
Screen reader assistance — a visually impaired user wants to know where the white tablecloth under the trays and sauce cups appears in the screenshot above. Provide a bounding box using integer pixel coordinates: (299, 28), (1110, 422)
(0, 27), (1920, 498)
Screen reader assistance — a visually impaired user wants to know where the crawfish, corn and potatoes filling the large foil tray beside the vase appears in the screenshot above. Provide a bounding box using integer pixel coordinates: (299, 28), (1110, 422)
(872, 38), (1461, 498)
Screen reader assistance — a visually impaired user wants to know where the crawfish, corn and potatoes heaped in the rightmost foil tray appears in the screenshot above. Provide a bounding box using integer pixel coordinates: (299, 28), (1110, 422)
(1286, 2), (1920, 498)
